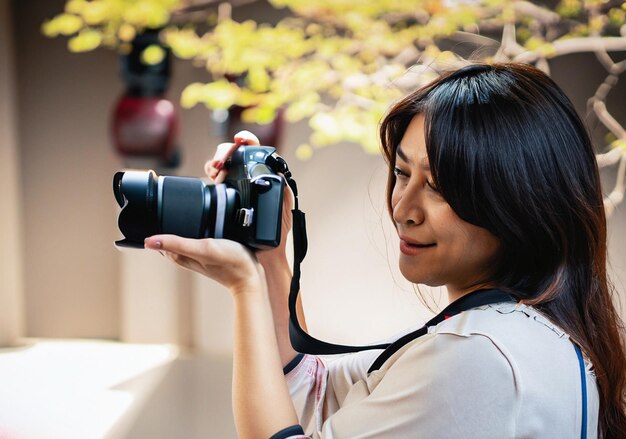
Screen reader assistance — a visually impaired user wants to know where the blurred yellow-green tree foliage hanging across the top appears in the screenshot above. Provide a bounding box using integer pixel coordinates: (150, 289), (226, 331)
(42, 0), (626, 158)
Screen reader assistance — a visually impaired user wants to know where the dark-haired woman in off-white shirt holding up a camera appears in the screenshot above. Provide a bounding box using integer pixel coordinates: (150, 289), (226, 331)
(146, 64), (626, 438)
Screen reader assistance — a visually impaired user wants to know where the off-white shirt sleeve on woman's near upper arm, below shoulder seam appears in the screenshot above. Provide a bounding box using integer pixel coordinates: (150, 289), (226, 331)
(303, 334), (518, 439)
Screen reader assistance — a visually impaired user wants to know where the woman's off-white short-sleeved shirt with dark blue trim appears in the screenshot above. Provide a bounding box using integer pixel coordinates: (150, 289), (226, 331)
(286, 303), (599, 439)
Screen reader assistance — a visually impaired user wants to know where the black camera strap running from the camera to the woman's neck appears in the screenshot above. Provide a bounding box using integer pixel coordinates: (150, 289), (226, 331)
(284, 172), (515, 373)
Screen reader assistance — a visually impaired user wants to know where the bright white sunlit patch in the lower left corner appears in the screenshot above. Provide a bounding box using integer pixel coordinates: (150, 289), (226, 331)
(0, 340), (178, 439)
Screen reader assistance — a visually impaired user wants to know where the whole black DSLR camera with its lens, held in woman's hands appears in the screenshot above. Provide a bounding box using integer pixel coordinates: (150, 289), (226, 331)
(113, 146), (285, 249)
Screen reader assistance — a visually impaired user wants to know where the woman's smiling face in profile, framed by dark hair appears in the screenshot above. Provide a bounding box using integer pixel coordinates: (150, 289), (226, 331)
(391, 115), (500, 300)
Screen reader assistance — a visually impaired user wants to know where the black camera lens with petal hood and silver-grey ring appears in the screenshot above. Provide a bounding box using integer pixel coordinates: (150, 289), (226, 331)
(113, 171), (239, 248)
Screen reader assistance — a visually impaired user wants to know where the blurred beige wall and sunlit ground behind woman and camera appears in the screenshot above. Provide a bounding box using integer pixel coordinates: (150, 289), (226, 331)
(0, 0), (626, 438)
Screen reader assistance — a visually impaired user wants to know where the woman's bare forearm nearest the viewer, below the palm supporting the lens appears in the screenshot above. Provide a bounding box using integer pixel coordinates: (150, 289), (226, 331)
(233, 288), (298, 439)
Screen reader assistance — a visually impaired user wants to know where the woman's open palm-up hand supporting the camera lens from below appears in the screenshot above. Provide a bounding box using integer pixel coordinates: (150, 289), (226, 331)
(144, 235), (265, 296)
